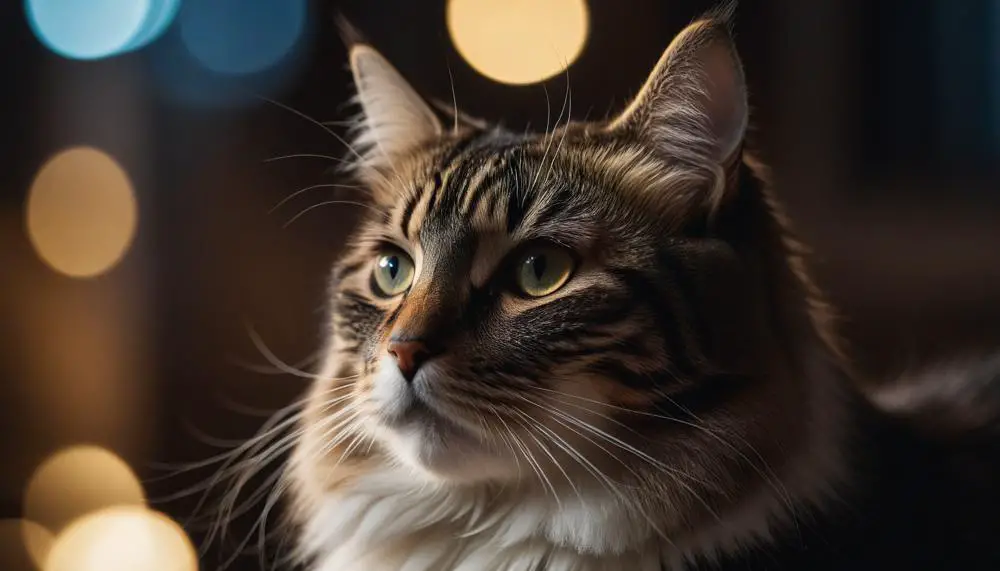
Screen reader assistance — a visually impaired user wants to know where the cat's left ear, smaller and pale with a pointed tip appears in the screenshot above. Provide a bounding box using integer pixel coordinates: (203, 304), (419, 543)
(350, 44), (442, 173)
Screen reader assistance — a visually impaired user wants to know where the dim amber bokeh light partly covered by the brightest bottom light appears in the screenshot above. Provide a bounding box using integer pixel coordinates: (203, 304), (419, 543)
(24, 446), (146, 534)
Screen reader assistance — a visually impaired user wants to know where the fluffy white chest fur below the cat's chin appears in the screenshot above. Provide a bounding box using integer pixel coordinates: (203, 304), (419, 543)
(301, 476), (664, 571)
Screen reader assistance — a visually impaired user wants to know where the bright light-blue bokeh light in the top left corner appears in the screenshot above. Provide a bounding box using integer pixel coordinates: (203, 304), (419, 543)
(25, 0), (180, 60)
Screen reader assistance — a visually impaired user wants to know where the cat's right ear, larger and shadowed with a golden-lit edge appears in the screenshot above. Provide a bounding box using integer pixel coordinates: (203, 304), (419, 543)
(611, 3), (748, 192)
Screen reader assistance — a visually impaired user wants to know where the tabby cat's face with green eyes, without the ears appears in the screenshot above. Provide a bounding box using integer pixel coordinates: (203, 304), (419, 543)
(326, 133), (701, 481)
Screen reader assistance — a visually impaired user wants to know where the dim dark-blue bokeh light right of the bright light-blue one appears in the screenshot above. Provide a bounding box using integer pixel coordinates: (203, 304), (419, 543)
(178, 0), (308, 75)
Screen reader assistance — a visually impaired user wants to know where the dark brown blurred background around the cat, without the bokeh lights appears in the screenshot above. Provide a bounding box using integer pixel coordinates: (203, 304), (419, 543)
(0, 0), (1000, 571)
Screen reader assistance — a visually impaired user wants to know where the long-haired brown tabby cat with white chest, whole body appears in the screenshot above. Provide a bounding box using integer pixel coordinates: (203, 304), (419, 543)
(285, 5), (1000, 571)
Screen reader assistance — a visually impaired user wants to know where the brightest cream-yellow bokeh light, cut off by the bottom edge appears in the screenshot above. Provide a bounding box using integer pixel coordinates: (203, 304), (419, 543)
(45, 508), (198, 571)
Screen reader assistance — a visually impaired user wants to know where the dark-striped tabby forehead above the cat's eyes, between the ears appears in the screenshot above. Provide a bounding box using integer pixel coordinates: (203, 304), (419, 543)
(391, 130), (662, 246)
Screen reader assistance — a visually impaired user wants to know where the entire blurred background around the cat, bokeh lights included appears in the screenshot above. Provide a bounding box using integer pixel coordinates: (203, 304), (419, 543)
(0, 0), (1000, 571)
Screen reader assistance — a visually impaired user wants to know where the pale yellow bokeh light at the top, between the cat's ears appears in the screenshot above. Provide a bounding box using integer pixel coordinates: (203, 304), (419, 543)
(447, 0), (589, 85)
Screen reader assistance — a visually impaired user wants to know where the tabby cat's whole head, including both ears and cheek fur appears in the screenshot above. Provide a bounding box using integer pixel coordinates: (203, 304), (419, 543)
(297, 6), (844, 544)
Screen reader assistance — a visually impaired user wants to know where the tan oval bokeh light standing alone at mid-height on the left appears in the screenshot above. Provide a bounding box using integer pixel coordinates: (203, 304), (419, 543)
(27, 147), (138, 278)
